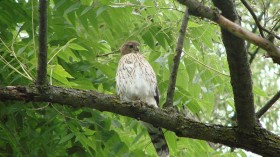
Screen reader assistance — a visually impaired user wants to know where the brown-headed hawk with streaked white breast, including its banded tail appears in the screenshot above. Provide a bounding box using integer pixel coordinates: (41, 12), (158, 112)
(116, 41), (169, 157)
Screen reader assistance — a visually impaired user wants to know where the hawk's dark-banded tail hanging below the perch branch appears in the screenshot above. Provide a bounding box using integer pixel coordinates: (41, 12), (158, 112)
(144, 122), (169, 157)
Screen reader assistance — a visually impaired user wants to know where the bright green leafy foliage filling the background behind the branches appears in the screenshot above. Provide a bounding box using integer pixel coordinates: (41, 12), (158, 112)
(0, 0), (280, 156)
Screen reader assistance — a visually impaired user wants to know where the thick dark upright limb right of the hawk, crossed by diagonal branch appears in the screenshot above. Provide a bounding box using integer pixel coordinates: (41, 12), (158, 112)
(212, 0), (256, 131)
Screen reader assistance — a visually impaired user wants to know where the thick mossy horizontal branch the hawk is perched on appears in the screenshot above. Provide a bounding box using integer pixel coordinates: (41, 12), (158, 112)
(0, 86), (280, 157)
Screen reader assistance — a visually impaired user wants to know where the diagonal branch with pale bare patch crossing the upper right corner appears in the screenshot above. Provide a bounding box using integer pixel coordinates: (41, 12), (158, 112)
(177, 0), (280, 64)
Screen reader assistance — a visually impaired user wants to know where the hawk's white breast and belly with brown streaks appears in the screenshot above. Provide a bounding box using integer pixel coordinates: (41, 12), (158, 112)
(116, 53), (157, 105)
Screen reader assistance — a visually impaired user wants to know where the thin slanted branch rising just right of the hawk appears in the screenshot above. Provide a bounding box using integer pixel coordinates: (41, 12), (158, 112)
(163, 7), (189, 107)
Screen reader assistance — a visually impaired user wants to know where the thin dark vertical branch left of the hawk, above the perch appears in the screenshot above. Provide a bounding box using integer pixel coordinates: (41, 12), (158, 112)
(36, 0), (48, 85)
